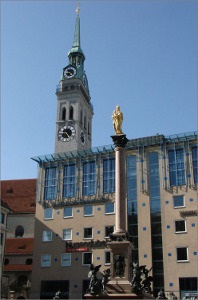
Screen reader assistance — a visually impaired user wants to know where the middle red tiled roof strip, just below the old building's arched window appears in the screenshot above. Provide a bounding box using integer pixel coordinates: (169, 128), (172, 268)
(5, 238), (34, 255)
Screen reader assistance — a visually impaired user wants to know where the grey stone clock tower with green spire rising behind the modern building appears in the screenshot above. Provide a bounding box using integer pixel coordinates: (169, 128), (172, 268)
(55, 8), (93, 153)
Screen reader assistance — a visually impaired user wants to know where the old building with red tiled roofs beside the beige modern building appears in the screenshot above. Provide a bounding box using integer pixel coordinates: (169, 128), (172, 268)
(1, 179), (37, 299)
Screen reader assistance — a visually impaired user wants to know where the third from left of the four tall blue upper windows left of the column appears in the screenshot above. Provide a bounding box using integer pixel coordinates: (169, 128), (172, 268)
(83, 161), (96, 196)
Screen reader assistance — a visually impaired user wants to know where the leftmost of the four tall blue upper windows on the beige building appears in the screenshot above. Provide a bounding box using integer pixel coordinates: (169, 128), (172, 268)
(44, 167), (57, 200)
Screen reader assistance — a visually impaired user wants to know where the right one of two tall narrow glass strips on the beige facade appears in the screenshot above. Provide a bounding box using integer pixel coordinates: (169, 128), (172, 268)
(148, 152), (164, 293)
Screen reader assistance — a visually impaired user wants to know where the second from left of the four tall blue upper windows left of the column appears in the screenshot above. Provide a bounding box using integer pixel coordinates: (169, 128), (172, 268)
(63, 164), (76, 198)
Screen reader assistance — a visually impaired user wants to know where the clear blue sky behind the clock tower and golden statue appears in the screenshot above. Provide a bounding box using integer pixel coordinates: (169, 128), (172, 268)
(1, 0), (197, 179)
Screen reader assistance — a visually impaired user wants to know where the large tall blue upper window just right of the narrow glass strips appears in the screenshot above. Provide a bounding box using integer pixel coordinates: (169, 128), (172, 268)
(168, 149), (186, 186)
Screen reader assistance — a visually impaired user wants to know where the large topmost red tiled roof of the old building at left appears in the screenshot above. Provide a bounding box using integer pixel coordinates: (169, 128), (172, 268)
(1, 179), (36, 213)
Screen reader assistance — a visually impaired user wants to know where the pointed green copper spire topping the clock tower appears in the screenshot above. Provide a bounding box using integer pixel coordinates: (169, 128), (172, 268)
(68, 7), (85, 60)
